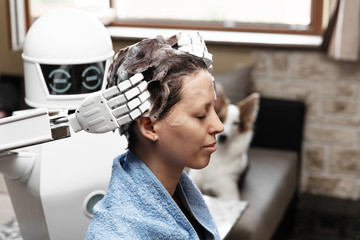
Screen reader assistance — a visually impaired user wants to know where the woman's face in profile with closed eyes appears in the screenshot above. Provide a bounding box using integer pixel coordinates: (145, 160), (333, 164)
(156, 71), (224, 169)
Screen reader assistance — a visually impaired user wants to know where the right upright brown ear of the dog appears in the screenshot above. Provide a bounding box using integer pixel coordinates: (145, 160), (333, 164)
(237, 93), (260, 132)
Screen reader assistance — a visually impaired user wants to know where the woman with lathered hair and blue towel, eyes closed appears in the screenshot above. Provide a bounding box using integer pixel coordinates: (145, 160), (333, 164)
(87, 35), (223, 239)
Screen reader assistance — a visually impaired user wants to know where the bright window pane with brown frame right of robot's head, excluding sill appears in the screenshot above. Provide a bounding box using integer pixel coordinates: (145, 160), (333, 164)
(112, 0), (323, 35)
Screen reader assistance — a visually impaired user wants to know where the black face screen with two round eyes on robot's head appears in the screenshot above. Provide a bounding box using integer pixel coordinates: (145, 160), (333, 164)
(40, 61), (106, 95)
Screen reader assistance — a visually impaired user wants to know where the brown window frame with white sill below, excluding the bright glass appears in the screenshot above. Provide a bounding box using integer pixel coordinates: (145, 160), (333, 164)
(19, 0), (329, 48)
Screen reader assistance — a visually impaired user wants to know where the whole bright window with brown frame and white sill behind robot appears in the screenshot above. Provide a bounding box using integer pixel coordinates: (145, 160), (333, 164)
(12, 0), (324, 49)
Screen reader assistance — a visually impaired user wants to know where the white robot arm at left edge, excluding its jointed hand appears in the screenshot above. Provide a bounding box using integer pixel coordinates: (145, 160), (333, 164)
(0, 108), (63, 181)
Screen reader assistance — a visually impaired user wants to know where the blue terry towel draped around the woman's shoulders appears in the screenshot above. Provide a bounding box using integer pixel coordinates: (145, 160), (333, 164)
(86, 151), (220, 240)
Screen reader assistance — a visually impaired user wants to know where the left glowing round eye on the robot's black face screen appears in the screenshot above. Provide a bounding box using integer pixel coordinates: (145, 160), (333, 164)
(48, 69), (71, 94)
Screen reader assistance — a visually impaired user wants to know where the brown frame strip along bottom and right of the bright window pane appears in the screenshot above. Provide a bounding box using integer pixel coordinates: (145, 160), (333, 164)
(110, 0), (323, 35)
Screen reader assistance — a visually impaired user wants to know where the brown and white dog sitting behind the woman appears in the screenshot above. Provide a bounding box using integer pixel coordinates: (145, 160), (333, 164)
(189, 84), (260, 200)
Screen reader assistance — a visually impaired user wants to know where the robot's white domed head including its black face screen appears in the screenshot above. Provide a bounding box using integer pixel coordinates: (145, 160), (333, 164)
(22, 9), (114, 109)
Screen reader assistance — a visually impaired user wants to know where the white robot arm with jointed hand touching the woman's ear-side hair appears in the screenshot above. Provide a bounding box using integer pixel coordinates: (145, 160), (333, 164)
(0, 73), (150, 152)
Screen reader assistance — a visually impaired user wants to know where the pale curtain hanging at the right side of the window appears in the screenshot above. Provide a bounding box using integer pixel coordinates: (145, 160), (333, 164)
(322, 0), (360, 61)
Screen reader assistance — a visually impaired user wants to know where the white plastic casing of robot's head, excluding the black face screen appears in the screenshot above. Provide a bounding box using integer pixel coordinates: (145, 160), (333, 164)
(22, 8), (114, 109)
